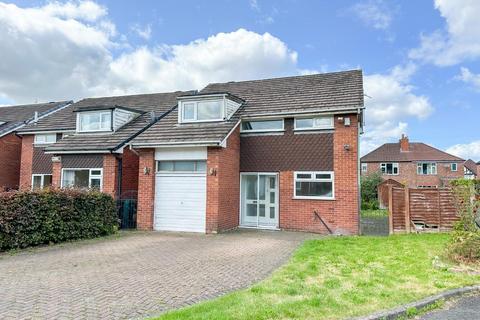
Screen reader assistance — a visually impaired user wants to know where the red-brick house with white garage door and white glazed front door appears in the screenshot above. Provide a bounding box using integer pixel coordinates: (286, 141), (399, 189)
(129, 70), (364, 234)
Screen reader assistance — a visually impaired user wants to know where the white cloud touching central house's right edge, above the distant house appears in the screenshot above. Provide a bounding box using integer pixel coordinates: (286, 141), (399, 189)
(361, 64), (433, 155)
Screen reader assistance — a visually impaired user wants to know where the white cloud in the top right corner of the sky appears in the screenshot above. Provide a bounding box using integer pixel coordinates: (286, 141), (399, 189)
(409, 0), (480, 66)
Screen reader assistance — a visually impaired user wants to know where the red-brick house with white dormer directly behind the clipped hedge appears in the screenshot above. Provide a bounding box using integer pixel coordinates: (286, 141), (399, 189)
(18, 92), (193, 199)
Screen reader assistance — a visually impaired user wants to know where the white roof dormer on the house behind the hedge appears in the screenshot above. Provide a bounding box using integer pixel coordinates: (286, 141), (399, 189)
(74, 106), (143, 133)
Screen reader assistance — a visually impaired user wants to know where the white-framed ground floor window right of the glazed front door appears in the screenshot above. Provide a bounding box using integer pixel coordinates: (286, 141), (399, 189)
(294, 171), (334, 199)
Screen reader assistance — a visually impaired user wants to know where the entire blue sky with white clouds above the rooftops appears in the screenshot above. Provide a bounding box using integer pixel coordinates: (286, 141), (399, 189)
(0, 0), (480, 161)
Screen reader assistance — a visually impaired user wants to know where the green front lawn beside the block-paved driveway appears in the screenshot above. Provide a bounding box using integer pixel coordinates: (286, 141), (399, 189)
(158, 234), (480, 319)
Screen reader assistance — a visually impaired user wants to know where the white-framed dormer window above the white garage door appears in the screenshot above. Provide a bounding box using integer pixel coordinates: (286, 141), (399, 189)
(181, 100), (224, 122)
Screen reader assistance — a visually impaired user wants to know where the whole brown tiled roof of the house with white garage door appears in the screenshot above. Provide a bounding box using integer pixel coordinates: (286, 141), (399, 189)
(129, 70), (363, 146)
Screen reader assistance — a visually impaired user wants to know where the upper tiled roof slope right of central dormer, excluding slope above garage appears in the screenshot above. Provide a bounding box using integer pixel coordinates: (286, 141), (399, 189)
(201, 70), (363, 116)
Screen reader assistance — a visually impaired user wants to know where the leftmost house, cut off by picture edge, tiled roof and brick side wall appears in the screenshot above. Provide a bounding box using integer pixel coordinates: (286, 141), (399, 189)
(0, 101), (71, 190)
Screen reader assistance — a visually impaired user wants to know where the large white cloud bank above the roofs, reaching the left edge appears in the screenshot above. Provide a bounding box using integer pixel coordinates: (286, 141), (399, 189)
(0, 1), (298, 103)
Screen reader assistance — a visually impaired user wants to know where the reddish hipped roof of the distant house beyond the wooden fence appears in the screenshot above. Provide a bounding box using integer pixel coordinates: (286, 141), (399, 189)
(360, 142), (464, 162)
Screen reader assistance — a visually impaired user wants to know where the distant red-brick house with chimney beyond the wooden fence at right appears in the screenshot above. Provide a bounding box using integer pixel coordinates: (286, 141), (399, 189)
(360, 135), (465, 188)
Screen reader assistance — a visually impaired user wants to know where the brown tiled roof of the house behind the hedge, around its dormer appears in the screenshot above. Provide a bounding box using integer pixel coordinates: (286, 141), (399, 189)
(46, 91), (194, 152)
